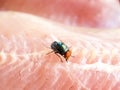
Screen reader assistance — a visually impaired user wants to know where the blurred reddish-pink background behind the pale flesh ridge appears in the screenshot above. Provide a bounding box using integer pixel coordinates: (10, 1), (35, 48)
(0, 0), (120, 28)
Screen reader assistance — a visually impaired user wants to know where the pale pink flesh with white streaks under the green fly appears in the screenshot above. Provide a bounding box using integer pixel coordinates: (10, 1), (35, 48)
(0, 12), (120, 90)
